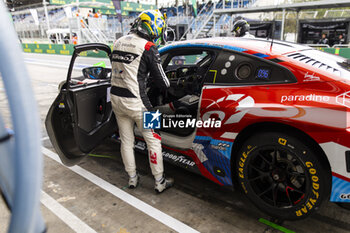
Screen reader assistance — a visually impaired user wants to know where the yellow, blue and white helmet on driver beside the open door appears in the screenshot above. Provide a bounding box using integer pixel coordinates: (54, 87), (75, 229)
(131, 10), (166, 46)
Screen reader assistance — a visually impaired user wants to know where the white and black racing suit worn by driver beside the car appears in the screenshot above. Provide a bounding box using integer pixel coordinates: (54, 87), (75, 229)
(111, 34), (170, 180)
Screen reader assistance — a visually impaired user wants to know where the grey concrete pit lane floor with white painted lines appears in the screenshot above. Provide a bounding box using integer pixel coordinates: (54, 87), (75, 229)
(0, 54), (350, 233)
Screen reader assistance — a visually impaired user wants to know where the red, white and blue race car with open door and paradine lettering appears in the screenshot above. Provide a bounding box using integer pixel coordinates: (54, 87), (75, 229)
(46, 38), (350, 220)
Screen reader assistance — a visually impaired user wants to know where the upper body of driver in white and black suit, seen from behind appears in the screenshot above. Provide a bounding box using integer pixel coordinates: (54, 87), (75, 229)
(111, 33), (169, 110)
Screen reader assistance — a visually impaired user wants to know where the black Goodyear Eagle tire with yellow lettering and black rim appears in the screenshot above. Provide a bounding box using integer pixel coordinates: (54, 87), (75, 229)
(236, 132), (331, 220)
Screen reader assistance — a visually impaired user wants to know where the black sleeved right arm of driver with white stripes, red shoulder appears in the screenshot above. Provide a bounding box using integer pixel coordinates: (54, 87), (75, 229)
(144, 42), (170, 90)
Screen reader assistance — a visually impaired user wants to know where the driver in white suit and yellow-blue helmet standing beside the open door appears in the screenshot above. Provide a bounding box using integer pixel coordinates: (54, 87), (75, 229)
(111, 10), (174, 193)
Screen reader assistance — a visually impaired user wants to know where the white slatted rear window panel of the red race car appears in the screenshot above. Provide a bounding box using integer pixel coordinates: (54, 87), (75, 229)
(288, 49), (350, 80)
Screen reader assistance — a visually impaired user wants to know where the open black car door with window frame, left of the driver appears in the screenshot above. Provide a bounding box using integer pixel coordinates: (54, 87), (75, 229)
(45, 43), (117, 166)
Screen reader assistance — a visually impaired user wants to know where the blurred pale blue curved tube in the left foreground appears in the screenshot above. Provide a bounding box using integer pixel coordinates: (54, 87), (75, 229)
(0, 1), (45, 233)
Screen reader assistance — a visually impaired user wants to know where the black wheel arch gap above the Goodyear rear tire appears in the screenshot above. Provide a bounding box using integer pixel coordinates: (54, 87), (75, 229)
(231, 122), (332, 190)
